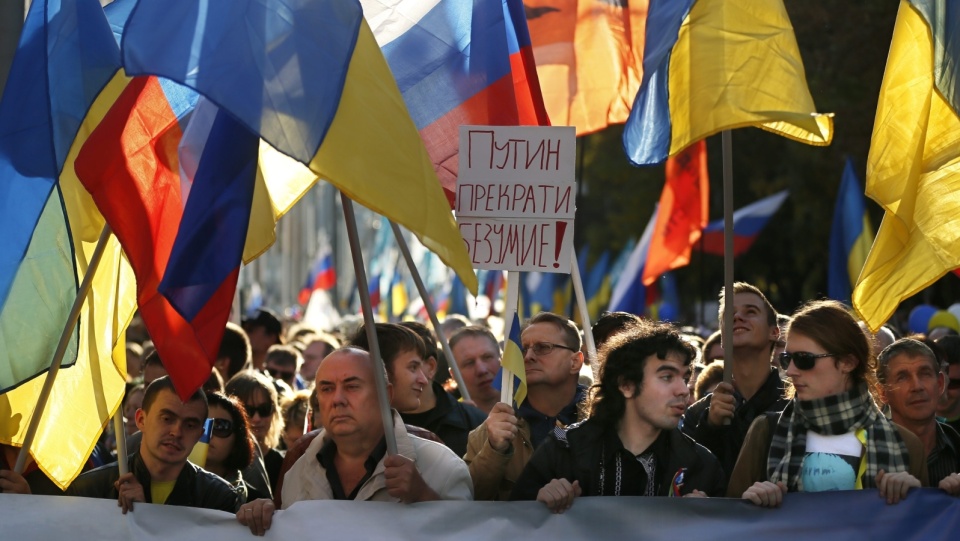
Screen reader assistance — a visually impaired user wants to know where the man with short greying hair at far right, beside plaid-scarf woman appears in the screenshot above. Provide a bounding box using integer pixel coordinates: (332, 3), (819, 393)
(877, 338), (960, 496)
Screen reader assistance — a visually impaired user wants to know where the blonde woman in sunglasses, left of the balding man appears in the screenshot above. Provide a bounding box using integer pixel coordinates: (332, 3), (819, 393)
(226, 370), (283, 492)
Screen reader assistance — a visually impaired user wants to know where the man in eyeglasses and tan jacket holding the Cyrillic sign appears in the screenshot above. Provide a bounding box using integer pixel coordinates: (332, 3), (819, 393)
(463, 312), (586, 500)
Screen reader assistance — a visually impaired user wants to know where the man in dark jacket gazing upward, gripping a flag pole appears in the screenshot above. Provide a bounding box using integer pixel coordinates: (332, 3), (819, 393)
(680, 282), (787, 474)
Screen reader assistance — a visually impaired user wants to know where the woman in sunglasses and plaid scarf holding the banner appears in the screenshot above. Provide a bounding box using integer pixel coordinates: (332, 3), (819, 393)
(727, 300), (927, 507)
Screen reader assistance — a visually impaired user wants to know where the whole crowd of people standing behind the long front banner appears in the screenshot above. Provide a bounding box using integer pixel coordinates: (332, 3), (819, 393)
(0, 282), (960, 535)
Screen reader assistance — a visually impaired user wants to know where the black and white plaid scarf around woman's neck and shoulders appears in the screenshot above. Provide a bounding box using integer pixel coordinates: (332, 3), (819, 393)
(767, 385), (907, 492)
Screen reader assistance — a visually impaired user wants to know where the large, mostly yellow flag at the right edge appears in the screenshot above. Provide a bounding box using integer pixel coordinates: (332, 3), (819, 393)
(853, 0), (960, 331)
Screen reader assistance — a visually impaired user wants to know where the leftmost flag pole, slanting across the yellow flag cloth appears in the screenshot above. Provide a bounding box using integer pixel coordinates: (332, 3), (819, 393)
(13, 224), (113, 474)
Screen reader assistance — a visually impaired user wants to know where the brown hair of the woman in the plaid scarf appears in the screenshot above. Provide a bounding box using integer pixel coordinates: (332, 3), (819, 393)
(787, 300), (877, 397)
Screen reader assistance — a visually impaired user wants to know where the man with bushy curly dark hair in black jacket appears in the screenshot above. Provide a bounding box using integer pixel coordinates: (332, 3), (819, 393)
(511, 324), (726, 513)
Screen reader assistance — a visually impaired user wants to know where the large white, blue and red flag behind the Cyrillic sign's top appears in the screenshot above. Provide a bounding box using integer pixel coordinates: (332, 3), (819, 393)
(361, 0), (548, 207)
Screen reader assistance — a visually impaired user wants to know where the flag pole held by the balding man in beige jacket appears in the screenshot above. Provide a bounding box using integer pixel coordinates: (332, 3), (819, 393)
(340, 192), (397, 455)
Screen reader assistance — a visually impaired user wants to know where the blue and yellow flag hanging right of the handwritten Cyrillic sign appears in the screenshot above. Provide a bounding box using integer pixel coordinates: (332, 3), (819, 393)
(623, 0), (833, 165)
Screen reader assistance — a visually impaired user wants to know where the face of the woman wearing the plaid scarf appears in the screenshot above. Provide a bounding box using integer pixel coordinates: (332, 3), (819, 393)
(785, 332), (854, 400)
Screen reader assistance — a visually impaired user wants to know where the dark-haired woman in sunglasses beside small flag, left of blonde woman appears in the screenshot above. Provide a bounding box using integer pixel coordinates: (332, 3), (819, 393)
(205, 392), (268, 501)
